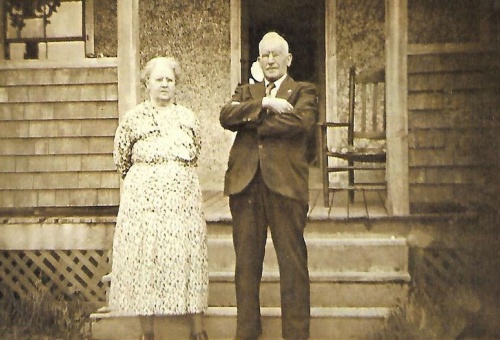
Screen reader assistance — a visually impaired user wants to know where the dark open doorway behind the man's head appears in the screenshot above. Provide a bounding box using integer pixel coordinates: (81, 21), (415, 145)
(241, 0), (325, 87)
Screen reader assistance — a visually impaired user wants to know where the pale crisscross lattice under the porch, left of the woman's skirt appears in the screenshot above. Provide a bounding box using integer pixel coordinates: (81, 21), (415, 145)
(0, 250), (110, 302)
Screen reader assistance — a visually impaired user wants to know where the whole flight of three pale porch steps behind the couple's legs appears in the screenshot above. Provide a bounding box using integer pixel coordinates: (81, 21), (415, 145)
(92, 234), (410, 340)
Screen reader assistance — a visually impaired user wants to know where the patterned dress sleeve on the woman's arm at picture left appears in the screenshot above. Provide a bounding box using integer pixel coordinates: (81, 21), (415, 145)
(113, 115), (136, 178)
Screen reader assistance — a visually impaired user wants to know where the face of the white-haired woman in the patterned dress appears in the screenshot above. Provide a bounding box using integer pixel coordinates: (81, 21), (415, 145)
(146, 62), (175, 106)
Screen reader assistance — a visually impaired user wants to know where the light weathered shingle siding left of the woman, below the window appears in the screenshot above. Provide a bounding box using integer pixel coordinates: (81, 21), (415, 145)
(0, 62), (120, 209)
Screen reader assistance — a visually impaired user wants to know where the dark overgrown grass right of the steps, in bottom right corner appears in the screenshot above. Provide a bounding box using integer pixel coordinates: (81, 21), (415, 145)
(371, 247), (500, 340)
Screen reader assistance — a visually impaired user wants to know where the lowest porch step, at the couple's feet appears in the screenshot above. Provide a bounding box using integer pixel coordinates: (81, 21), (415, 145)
(91, 307), (390, 340)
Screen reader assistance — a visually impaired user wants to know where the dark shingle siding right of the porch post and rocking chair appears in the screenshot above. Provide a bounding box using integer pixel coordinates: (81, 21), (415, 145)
(408, 52), (500, 204)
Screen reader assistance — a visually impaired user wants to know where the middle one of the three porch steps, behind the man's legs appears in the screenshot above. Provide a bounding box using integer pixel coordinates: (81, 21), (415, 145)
(209, 272), (410, 307)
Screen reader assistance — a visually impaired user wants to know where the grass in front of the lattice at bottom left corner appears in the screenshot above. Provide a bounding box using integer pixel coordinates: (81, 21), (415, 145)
(0, 282), (91, 340)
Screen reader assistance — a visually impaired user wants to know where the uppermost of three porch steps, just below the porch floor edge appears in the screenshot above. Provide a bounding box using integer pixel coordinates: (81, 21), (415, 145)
(208, 236), (408, 273)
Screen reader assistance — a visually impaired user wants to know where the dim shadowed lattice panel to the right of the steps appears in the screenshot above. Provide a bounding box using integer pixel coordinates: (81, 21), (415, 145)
(415, 248), (473, 296)
